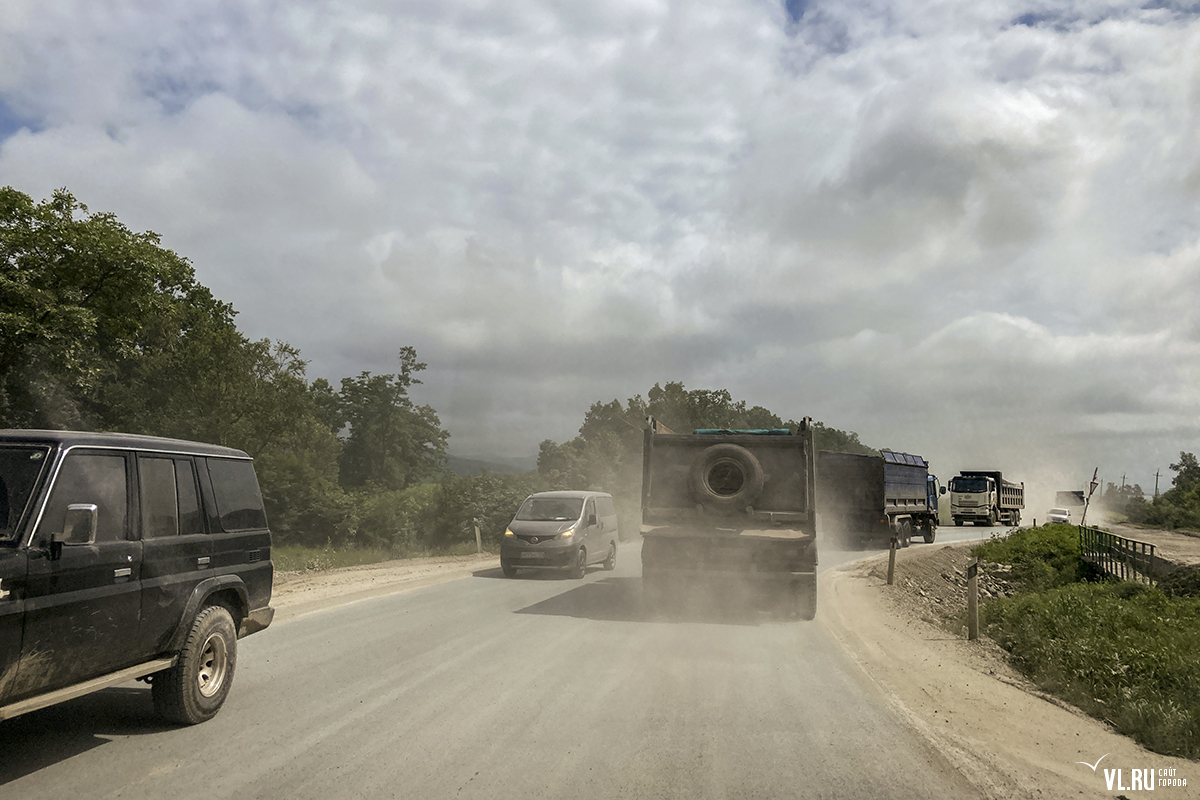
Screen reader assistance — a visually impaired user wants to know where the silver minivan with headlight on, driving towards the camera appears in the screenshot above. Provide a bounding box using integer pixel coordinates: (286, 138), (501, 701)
(500, 492), (619, 578)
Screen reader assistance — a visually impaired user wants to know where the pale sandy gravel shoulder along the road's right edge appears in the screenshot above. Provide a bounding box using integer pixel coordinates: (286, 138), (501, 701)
(817, 542), (1200, 800)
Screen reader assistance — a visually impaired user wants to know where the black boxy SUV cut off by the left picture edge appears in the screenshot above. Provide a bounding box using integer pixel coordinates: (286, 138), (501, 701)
(0, 431), (275, 723)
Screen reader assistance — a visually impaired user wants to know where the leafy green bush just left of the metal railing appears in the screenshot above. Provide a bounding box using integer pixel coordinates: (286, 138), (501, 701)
(974, 525), (1086, 591)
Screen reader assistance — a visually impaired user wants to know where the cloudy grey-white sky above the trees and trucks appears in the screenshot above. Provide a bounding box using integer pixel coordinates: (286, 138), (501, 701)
(0, 0), (1200, 503)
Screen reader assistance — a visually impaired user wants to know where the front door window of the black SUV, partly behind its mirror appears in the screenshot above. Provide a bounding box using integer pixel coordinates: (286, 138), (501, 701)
(40, 452), (128, 542)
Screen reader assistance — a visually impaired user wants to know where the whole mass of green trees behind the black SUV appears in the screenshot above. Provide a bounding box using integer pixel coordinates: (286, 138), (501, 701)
(0, 187), (463, 546)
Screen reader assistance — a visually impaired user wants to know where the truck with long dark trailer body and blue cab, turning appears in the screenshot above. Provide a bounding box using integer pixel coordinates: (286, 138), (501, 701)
(817, 450), (944, 547)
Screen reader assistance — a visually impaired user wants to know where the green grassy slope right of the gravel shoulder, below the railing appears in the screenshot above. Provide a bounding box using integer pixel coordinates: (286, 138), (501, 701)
(976, 525), (1200, 759)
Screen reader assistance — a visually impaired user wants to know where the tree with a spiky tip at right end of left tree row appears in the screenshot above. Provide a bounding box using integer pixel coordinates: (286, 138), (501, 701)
(340, 347), (450, 491)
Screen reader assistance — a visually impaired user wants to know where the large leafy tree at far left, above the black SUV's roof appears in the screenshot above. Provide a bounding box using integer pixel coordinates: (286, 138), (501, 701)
(0, 187), (226, 427)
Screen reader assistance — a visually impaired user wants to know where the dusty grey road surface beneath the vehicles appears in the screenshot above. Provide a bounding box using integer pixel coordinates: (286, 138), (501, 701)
(0, 528), (985, 800)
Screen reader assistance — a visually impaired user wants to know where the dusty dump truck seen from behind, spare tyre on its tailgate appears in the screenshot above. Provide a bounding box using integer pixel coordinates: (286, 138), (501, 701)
(641, 417), (817, 619)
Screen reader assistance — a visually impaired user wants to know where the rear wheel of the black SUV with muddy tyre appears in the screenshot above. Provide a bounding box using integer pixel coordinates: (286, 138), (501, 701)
(150, 606), (238, 724)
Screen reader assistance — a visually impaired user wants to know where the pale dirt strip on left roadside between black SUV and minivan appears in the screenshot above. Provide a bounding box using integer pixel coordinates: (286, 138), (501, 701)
(271, 553), (500, 622)
